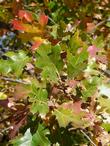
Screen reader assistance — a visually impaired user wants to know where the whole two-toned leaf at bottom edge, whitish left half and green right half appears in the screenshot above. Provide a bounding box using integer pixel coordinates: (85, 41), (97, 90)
(11, 125), (50, 146)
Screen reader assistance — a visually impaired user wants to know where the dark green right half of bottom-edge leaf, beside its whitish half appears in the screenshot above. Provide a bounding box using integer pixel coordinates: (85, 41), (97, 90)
(32, 124), (51, 146)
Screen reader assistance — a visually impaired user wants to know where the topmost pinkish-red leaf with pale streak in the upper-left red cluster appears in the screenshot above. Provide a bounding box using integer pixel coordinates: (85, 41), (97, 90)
(18, 10), (33, 22)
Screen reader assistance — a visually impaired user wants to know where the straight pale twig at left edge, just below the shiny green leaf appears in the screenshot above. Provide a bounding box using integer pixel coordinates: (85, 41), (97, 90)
(0, 77), (30, 85)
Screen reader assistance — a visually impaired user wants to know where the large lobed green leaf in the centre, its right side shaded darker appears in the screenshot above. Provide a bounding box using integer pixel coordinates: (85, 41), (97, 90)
(35, 45), (63, 82)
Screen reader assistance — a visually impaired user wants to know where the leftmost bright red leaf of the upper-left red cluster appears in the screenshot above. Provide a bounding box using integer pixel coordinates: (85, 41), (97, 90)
(12, 20), (25, 31)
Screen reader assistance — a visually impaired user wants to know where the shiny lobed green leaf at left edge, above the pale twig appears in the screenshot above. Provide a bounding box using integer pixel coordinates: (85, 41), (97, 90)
(0, 51), (29, 77)
